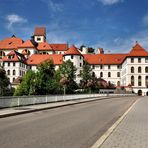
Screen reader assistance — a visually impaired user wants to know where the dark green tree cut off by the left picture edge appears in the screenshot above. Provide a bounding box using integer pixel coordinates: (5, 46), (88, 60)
(0, 67), (10, 96)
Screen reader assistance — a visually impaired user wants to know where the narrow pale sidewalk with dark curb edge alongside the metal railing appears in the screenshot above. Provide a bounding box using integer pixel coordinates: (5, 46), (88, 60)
(0, 97), (109, 118)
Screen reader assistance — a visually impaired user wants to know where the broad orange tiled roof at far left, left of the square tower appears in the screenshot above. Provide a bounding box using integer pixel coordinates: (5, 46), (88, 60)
(0, 36), (23, 50)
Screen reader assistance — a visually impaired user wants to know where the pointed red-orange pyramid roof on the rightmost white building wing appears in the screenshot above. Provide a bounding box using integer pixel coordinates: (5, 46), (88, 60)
(129, 43), (148, 56)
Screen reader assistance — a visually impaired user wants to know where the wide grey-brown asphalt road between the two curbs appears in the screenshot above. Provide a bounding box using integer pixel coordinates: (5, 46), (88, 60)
(0, 97), (137, 148)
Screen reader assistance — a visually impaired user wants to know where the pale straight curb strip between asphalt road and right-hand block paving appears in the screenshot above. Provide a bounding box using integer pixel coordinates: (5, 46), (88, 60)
(91, 99), (140, 148)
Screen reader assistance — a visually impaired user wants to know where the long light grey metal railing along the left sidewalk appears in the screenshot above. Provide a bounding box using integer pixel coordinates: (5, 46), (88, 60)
(0, 94), (133, 108)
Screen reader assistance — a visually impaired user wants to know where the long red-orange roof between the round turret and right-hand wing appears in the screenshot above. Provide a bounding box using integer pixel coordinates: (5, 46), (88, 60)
(83, 54), (127, 65)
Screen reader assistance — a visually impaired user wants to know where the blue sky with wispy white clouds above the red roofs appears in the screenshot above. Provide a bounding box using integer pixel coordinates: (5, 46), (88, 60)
(0, 0), (148, 52)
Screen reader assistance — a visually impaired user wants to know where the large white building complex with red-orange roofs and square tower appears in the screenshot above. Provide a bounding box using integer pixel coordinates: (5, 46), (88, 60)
(0, 27), (148, 95)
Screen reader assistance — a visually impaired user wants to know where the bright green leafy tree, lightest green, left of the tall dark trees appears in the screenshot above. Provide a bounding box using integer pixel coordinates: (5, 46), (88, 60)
(14, 70), (36, 96)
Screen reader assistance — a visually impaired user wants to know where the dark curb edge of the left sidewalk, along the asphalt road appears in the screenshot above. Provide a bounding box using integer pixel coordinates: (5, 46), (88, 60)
(0, 96), (135, 118)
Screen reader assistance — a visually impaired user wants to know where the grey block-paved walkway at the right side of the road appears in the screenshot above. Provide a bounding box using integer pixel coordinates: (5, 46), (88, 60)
(101, 97), (148, 148)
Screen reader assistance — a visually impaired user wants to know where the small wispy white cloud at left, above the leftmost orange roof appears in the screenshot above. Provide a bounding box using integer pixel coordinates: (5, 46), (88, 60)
(5, 14), (27, 31)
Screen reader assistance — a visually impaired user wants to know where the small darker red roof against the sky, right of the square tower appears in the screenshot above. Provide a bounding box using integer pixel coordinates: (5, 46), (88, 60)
(49, 44), (68, 51)
